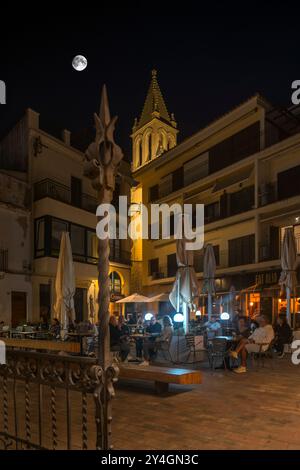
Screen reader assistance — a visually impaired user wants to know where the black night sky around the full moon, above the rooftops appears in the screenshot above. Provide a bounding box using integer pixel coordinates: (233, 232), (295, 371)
(0, 8), (300, 158)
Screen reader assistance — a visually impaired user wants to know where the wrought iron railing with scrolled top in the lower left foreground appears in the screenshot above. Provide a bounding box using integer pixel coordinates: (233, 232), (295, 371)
(0, 349), (117, 450)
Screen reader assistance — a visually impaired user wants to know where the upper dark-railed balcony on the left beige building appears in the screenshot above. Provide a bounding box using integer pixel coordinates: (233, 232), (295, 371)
(34, 178), (97, 214)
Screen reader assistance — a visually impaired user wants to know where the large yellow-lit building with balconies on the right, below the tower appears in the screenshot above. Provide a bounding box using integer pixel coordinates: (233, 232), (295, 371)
(132, 73), (300, 322)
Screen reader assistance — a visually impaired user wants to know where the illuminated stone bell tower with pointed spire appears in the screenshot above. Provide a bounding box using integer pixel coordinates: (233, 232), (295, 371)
(131, 70), (178, 171)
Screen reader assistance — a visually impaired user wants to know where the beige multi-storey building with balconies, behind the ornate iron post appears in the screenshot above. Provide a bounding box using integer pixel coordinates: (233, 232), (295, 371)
(0, 109), (130, 321)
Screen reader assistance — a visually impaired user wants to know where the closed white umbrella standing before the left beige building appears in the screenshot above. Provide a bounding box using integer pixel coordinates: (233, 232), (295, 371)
(54, 232), (76, 332)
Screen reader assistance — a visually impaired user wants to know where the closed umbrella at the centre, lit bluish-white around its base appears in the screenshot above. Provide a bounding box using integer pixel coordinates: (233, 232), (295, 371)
(169, 238), (199, 333)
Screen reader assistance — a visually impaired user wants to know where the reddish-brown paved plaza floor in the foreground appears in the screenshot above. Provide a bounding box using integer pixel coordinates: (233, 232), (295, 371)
(0, 356), (300, 450)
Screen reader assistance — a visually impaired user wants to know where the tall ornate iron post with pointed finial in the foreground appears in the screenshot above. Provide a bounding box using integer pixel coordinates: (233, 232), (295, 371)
(84, 85), (123, 449)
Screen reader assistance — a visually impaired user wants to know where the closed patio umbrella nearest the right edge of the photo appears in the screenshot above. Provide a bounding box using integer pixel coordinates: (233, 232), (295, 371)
(279, 227), (297, 324)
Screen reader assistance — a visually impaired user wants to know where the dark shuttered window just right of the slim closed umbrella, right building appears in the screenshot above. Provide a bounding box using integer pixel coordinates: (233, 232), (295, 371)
(228, 234), (255, 266)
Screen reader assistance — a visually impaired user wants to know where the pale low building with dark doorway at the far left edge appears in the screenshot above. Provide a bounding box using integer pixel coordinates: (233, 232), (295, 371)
(0, 170), (32, 325)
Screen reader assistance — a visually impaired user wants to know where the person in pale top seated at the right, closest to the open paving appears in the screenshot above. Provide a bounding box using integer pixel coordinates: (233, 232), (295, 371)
(230, 315), (274, 374)
